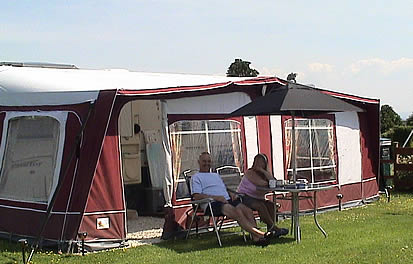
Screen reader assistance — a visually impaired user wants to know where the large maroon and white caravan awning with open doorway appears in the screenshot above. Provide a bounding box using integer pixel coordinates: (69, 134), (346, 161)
(0, 65), (380, 249)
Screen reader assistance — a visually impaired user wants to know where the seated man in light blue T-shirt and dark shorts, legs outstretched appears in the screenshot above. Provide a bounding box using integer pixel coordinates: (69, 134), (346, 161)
(192, 152), (273, 246)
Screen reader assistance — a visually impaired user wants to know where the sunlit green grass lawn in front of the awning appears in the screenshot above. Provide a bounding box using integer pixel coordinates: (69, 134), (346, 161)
(0, 194), (413, 264)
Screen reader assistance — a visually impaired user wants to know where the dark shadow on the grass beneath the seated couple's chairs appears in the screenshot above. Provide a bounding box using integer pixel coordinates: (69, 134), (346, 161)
(154, 232), (294, 253)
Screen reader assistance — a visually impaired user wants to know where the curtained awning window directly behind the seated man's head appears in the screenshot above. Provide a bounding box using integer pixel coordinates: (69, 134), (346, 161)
(169, 120), (243, 198)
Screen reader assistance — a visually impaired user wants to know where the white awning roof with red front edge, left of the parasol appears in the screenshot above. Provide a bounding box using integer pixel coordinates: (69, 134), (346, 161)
(0, 66), (284, 106)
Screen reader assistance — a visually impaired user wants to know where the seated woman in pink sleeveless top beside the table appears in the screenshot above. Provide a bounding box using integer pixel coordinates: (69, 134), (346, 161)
(237, 154), (288, 236)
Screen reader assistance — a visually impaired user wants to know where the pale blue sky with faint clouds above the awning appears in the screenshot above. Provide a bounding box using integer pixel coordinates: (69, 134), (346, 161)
(0, 0), (413, 118)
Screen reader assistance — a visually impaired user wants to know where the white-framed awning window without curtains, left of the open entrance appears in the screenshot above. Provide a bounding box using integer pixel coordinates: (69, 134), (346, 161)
(0, 116), (59, 202)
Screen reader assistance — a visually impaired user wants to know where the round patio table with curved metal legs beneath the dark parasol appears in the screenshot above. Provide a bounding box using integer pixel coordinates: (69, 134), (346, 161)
(257, 184), (337, 243)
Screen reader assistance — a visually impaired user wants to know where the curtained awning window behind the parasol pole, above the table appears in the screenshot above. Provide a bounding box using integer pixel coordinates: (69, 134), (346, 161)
(284, 119), (337, 182)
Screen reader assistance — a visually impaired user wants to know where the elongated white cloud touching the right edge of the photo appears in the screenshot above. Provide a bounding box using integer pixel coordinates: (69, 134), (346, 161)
(350, 57), (413, 74)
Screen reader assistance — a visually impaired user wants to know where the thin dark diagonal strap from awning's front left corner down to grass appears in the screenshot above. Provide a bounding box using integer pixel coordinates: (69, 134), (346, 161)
(27, 101), (95, 263)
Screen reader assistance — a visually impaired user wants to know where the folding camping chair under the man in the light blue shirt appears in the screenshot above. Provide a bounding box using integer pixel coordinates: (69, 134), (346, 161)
(183, 170), (247, 247)
